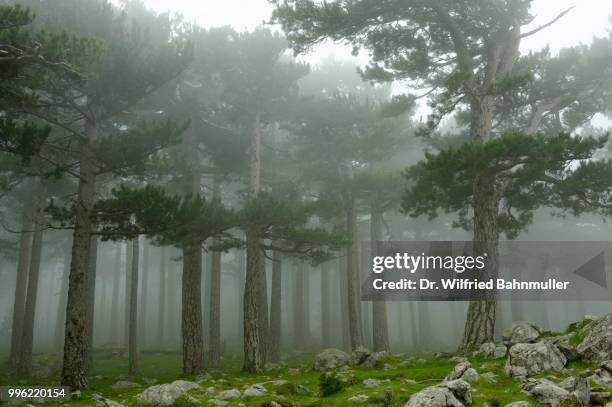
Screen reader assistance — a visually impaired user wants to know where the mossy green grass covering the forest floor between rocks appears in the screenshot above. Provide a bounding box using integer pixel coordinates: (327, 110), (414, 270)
(0, 350), (596, 407)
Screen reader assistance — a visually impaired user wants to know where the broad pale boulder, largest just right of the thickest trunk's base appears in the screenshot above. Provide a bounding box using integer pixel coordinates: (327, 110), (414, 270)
(504, 341), (567, 377)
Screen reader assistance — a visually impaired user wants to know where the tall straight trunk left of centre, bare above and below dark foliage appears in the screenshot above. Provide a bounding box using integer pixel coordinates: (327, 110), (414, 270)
(242, 115), (265, 373)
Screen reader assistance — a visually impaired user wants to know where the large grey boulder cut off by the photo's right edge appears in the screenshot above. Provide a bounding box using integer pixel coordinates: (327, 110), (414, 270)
(578, 314), (612, 363)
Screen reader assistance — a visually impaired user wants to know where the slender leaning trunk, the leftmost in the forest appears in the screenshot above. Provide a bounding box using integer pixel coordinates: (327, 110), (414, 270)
(9, 202), (33, 369)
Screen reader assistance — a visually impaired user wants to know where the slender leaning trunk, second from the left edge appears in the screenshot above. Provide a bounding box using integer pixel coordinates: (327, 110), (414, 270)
(17, 197), (43, 376)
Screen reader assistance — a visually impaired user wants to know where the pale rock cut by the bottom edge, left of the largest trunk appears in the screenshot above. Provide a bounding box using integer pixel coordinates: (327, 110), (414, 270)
(404, 380), (472, 407)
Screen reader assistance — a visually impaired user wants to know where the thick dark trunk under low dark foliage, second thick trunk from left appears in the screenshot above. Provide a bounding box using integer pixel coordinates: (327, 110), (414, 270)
(181, 245), (204, 375)
